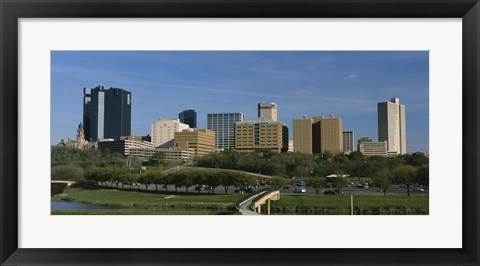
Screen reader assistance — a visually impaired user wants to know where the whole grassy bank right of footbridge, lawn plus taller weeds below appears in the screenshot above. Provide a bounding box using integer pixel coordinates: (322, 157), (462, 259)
(271, 195), (429, 215)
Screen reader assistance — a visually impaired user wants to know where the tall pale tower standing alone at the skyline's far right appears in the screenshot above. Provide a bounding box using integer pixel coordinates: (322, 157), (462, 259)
(377, 98), (407, 154)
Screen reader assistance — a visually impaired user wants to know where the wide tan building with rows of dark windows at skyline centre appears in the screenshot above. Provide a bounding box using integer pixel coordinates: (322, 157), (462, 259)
(235, 116), (288, 153)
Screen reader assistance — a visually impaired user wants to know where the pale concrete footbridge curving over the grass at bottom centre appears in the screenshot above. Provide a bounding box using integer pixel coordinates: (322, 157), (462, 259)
(237, 189), (280, 215)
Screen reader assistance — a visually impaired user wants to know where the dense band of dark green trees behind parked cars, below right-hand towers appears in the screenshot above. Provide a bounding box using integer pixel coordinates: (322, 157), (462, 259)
(195, 150), (429, 185)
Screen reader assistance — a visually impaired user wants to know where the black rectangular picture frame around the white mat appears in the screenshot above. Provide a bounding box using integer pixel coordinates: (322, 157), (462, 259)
(0, 0), (480, 265)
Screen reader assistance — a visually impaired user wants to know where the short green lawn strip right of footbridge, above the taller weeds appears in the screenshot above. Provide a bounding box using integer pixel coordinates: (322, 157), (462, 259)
(272, 195), (428, 208)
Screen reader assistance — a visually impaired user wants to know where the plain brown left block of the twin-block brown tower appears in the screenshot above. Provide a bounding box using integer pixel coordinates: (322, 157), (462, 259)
(293, 115), (313, 154)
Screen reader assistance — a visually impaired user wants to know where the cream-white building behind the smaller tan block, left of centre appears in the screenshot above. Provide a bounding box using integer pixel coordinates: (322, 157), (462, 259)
(150, 118), (189, 147)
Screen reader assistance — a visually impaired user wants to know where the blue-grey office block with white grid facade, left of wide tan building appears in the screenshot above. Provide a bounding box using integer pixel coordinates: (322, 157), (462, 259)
(207, 113), (245, 151)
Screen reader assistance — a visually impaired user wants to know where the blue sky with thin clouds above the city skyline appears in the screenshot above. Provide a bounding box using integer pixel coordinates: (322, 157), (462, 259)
(51, 51), (429, 153)
